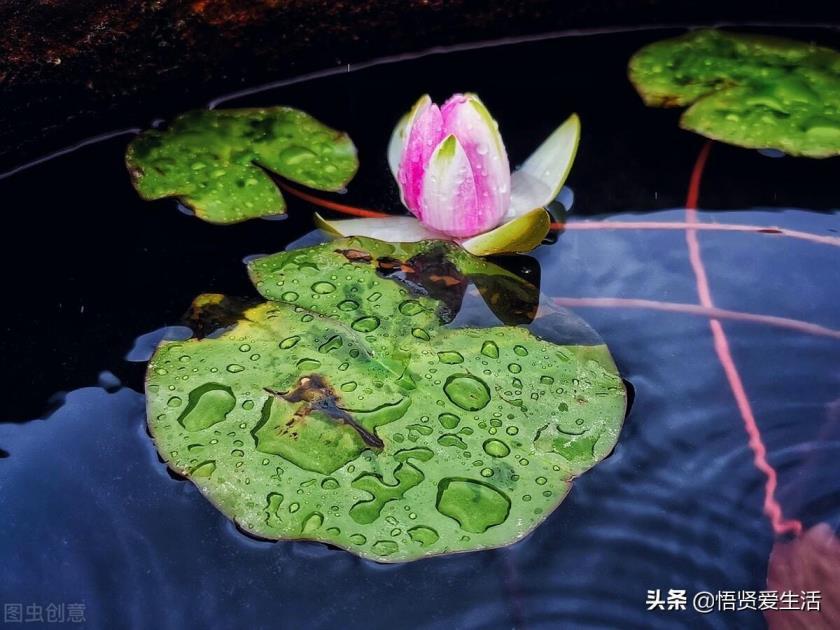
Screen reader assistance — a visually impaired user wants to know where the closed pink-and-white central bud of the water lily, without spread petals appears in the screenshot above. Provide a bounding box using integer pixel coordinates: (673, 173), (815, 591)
(397, 94), (510, 238)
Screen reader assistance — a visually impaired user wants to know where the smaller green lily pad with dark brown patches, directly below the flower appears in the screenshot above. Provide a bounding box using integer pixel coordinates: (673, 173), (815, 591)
(248, 238), (539, 330)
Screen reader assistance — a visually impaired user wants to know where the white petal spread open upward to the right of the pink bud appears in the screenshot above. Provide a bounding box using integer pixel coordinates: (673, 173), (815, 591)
(505, 114), (580, 221)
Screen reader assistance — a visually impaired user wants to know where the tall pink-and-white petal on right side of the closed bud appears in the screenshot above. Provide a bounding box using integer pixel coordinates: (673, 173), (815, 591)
(440, 94), (510, 231)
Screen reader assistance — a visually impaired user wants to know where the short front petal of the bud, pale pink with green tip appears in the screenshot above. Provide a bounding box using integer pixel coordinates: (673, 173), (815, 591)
(420, 135), (480, 237)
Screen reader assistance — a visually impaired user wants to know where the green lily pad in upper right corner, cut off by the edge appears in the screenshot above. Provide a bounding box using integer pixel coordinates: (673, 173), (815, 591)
(629, 30), (840, 157)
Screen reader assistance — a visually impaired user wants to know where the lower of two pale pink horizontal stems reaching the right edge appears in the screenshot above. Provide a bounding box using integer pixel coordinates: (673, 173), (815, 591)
(554, 297), (840, 339)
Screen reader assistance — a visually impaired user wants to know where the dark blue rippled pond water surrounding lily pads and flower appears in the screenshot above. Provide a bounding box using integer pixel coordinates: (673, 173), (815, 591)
(0, 29), (840, 628)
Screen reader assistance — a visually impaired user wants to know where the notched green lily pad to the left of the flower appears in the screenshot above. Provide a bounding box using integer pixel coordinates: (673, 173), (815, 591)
(126, 107), (359, 223)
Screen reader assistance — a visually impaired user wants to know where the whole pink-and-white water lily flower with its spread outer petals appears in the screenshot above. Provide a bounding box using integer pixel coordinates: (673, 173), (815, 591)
(317, 94), (580, 255)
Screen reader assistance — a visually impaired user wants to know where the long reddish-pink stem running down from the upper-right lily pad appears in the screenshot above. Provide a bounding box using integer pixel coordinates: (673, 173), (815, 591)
(685, 141), (802, 535)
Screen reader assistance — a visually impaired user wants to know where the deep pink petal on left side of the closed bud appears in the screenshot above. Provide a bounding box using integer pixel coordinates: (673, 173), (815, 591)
(397, 99), (444, 220)
